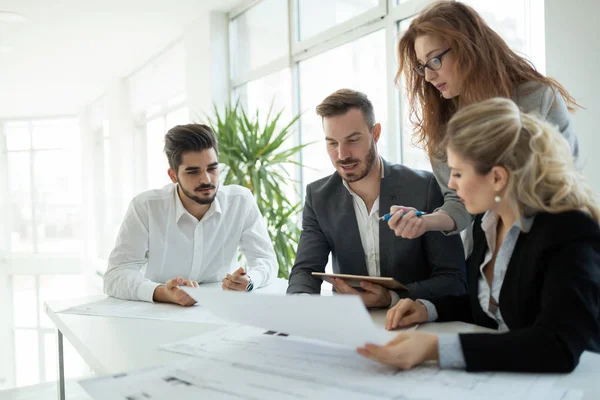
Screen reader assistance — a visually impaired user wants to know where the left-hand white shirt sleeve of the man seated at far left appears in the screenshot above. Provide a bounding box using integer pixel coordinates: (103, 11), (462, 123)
(104, 199), (159, 302)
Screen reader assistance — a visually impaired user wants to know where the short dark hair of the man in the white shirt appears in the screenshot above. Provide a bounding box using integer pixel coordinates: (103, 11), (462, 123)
(165, 124), (219, 173)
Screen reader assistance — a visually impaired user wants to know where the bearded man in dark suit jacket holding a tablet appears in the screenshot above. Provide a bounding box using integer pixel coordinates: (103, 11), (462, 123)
(287, 89), (466, 307)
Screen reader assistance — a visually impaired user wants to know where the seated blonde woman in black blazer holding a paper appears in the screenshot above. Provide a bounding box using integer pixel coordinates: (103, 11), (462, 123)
(358, 98), (600, 372)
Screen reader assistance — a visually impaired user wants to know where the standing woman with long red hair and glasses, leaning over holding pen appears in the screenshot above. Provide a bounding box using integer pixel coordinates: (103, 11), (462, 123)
(389, 1), (578, 239)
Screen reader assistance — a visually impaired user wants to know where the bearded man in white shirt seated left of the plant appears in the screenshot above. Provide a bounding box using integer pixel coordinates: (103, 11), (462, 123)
(104, 124), (278, 306)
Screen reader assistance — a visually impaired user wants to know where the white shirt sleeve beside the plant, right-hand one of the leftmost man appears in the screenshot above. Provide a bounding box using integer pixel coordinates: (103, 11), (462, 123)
(240, 195), (279, 288)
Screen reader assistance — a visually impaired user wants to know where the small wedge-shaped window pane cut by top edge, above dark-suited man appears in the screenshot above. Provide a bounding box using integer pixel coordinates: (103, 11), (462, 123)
(298, 0), (380, 40)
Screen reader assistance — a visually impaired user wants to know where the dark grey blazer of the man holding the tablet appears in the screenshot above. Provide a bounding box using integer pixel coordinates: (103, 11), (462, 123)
(287, 161), (467, 299)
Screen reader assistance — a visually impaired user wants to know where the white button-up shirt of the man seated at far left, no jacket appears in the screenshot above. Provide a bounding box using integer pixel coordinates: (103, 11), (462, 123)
(104, 184), (278, 302)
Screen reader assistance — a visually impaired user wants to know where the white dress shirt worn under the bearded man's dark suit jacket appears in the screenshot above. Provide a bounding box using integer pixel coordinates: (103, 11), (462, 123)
(342, 159), (400, 307)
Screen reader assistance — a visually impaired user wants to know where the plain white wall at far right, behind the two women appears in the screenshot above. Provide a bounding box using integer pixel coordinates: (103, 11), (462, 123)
(545, 0), (600, 193)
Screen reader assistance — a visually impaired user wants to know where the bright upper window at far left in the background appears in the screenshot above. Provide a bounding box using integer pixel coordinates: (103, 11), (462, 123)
(3, 119), (82, 254)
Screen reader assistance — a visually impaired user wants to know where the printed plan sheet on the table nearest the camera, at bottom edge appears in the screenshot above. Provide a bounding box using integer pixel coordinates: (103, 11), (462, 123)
(80, 359), (386, 400)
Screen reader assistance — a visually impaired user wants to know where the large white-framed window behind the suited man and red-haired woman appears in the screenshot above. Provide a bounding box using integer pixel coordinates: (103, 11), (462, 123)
(230, 0), (543, 198)
